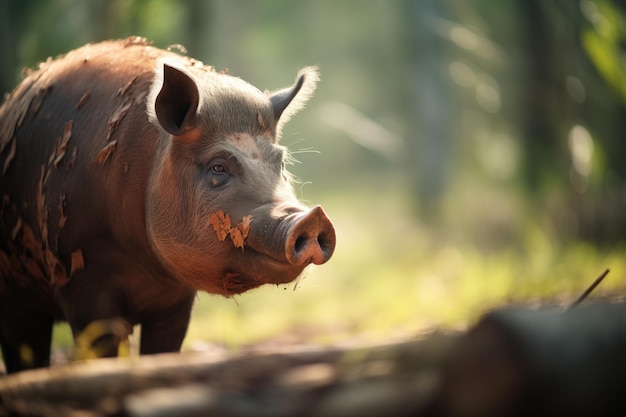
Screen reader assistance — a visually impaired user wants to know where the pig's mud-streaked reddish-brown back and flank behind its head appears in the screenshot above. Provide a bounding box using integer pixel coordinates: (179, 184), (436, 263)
(0, 38), (182, 290)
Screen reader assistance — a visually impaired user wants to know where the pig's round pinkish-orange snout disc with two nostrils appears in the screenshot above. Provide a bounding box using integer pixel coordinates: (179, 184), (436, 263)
(285, 206), (336, 266)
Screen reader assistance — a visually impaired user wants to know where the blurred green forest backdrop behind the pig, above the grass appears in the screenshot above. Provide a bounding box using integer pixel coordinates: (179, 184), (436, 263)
(0, 0), (626, 242)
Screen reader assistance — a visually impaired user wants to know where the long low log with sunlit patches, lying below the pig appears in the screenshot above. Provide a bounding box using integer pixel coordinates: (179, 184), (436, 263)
(0, 334), (455, 417)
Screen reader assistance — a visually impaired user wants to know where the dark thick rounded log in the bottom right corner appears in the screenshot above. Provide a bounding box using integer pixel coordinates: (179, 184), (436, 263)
(437, 302), (626, 417)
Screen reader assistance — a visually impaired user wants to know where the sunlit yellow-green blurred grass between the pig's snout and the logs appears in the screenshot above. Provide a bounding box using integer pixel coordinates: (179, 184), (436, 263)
(55, 174), (626, 349)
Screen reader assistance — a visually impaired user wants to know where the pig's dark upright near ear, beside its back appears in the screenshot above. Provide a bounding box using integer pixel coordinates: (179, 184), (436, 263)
(148, 63), (200, 136)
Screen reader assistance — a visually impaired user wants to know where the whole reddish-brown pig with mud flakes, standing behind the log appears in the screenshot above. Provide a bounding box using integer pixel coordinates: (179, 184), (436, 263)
(0, 37), (335, 373)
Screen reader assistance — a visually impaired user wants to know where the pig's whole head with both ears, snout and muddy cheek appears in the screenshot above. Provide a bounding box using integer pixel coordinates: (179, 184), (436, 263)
(146, 63), (335, 295)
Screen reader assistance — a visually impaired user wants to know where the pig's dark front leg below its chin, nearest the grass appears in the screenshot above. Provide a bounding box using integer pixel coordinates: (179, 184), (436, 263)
(140, 293), (195, 355)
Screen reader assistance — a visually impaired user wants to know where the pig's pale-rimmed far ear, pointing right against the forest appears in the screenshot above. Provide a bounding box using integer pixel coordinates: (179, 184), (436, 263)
(270, 67), (319, 134)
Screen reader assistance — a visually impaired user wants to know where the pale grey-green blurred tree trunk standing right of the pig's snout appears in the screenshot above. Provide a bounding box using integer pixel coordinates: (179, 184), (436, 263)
(402, 0), (457, 220)
